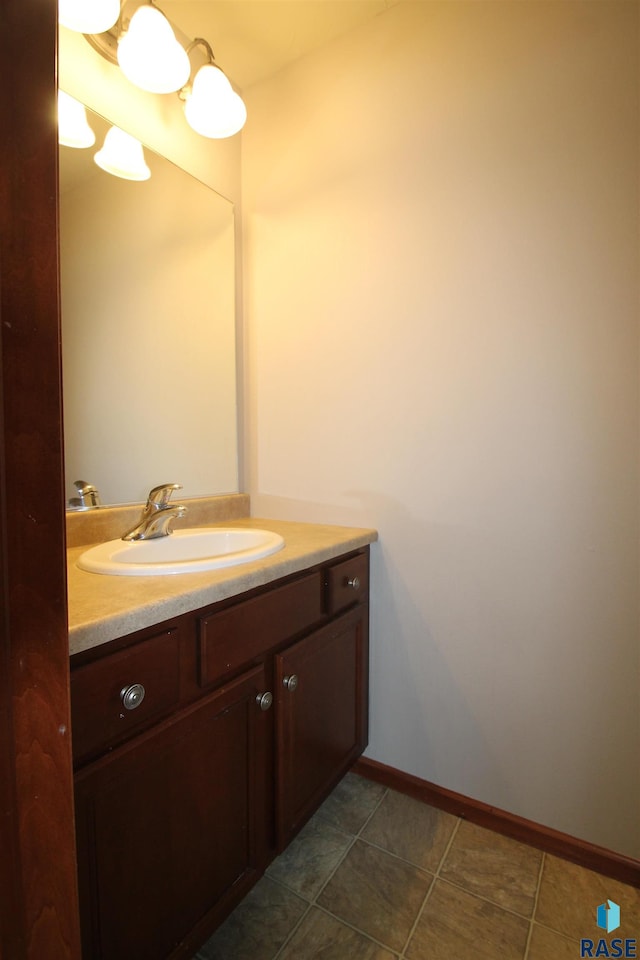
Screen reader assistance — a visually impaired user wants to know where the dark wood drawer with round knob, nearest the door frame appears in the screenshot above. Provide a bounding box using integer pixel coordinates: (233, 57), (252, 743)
(71, 628), (180, 761)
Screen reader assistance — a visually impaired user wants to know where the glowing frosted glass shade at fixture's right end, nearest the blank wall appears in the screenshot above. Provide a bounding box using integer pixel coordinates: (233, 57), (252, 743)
(184, 63), (247, 140)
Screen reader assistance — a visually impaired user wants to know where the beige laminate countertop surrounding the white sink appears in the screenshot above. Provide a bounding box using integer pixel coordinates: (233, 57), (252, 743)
(67, 517), (378, 654)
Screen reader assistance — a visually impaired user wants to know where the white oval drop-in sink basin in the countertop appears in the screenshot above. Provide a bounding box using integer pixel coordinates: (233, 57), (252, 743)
(78, 527), (284, 577)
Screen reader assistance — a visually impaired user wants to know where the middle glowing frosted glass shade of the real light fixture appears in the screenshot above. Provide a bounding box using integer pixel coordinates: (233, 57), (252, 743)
(118, 4), (191, 93)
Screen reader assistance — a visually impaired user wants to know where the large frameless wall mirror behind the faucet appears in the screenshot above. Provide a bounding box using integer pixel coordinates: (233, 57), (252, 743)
(60, 104), (238, 504)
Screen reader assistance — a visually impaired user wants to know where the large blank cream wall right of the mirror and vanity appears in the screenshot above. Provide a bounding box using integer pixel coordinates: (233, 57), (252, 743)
(242, 0), (640, 856)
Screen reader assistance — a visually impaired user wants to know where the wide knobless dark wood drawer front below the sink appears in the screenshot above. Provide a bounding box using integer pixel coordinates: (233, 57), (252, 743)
(199, 572), (322, 686)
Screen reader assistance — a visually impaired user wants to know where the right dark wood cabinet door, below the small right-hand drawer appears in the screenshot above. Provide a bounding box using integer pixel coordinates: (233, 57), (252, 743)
(274, 604), (368, 849)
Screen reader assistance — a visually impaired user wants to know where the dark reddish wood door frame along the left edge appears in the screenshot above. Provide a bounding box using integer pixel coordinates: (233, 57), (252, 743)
(0, 0), (80, 960)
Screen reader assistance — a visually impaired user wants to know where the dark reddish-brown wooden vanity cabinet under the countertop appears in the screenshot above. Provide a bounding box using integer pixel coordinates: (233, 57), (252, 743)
(71, 548), (369, 960)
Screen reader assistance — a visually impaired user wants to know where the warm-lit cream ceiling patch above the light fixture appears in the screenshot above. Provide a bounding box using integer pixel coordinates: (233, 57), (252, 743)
(158, 0), (400, 90)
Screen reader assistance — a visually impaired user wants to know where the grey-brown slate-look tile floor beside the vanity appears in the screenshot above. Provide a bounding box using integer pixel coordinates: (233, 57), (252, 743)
(195, 774), (640, 960)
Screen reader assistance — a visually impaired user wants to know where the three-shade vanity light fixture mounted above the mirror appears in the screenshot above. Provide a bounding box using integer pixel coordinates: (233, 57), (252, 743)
(59, 0), (247, 139)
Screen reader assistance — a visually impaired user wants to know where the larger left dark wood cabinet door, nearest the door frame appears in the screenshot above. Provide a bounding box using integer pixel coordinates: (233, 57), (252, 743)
(76, 666), (273, 960)
